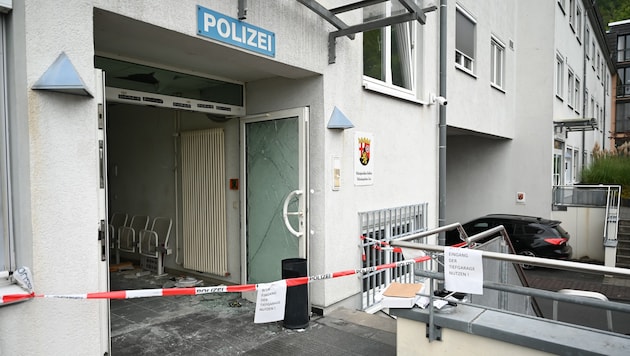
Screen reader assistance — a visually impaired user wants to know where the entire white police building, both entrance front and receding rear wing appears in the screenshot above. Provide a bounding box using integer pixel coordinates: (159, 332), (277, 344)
(0, 0), (612, 355)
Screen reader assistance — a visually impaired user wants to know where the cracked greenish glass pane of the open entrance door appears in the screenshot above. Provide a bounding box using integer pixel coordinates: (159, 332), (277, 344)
(245, 117), (299, 283)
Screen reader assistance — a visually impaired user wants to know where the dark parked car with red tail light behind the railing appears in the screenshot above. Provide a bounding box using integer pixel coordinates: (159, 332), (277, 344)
(446, 214), (573, 267)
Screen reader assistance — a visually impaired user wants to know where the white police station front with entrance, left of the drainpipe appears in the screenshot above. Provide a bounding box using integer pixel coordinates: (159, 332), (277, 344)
(0, 0), (438, 355)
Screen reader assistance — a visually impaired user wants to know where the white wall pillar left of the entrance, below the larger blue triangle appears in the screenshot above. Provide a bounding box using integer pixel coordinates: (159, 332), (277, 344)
(0, 1), (109, 355)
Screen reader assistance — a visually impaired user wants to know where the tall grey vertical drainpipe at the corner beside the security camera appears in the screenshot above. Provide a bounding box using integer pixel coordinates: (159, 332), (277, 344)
(436, 0), (447, 245)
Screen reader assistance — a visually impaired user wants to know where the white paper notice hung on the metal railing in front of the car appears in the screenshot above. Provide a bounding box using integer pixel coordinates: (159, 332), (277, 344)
(444, 247), (483, 294)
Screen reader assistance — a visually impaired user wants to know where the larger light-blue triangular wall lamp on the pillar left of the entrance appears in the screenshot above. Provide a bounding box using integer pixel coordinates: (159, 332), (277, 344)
(33, 52), (93, 97)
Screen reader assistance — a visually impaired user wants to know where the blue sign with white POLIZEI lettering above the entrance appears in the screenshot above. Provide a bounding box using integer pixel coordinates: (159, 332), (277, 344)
(197, 6), (276, 57)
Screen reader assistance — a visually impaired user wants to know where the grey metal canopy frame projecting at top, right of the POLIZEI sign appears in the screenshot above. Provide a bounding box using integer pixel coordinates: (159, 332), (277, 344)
(297, 0), (437, 64)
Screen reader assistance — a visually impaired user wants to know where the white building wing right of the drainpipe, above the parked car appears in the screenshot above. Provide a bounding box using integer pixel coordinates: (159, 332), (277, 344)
(446, 0), (614, 222)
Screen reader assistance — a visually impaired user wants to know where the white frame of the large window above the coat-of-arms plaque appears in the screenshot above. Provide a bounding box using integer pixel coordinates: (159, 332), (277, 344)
(362, 1), (421, 103)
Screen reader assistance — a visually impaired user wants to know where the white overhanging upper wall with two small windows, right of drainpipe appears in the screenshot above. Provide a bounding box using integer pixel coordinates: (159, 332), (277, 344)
(446, 0), (520, 138)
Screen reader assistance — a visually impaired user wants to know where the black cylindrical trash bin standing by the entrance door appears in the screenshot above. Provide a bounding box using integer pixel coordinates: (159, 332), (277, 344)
(282, 258), (309, 329)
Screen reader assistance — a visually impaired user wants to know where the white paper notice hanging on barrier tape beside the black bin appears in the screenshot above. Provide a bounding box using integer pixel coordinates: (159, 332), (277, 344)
(254, 280), (287, 324)
